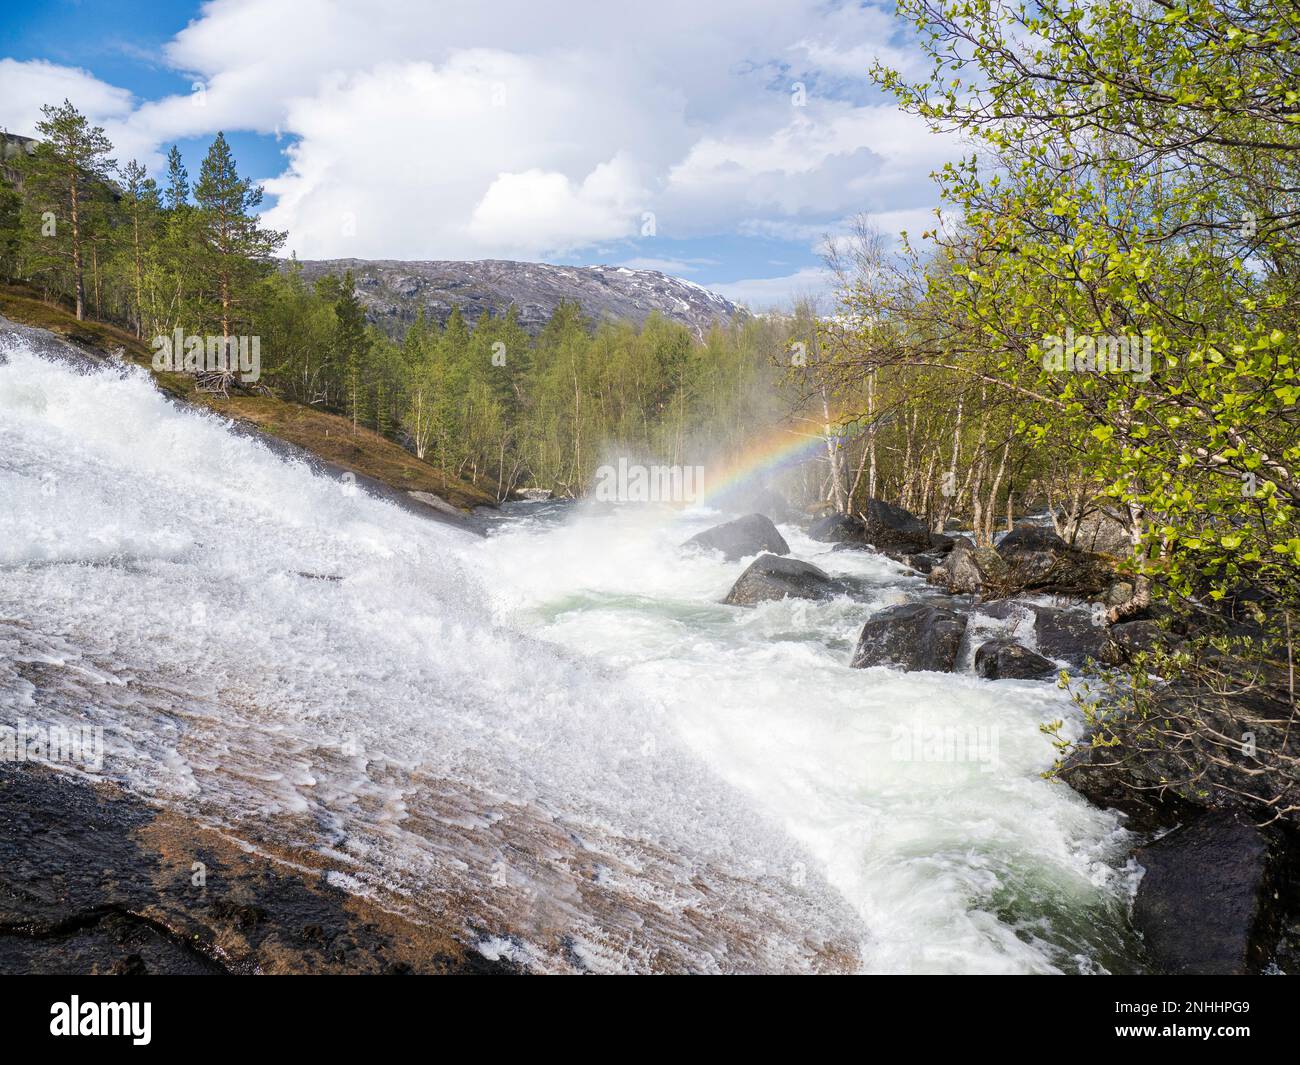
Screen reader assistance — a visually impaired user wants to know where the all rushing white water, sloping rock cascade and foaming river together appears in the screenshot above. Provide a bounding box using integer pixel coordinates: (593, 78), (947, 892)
(0, 342), (1127, 971)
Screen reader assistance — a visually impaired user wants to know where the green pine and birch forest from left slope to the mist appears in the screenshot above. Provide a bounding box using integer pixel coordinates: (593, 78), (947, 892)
(0, 109), (810, 499)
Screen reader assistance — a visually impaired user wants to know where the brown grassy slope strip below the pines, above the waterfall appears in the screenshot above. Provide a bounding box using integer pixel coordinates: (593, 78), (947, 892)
(0, 285), (495, 508)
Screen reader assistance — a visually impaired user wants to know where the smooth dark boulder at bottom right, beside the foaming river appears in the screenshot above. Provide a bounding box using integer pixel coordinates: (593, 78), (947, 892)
(1132, 811), (1282, 977)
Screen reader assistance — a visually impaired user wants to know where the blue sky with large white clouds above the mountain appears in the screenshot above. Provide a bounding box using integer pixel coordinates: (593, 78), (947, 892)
(0, 0), (957, 309)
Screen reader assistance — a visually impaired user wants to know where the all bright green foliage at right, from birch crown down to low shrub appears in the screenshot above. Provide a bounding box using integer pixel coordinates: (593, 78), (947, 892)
(846, 0), (1300, 815)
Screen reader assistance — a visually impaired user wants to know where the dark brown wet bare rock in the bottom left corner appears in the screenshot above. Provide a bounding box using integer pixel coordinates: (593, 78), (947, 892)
(0, 765), (517, 975)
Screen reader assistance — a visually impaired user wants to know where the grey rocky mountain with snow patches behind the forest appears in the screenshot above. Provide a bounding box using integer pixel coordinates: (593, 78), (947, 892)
(292, 259), (746, 335)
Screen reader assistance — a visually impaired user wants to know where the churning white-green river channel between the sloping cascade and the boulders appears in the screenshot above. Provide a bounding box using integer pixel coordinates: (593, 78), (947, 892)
(465, 507), (1131, 973)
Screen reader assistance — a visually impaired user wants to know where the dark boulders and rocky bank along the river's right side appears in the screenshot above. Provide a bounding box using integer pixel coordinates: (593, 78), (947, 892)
(692, 501), (1300, 974)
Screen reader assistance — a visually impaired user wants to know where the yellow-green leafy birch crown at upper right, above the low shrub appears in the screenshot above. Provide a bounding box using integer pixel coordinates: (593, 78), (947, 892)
(857, 0), (1300, 616)
